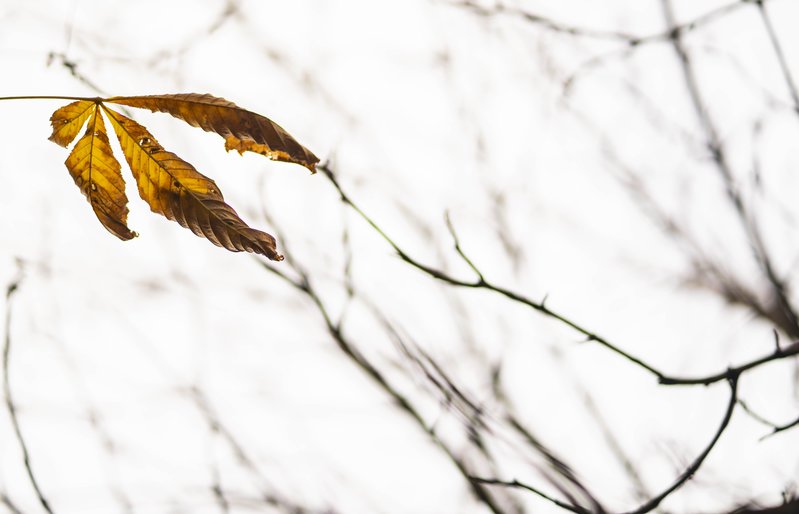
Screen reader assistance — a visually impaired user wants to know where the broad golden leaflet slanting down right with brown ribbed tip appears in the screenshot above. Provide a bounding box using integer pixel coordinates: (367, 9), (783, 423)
(102, 105), (283, 261)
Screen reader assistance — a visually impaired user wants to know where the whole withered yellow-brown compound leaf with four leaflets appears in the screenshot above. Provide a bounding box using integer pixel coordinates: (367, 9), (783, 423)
(40, 90), (319, 260)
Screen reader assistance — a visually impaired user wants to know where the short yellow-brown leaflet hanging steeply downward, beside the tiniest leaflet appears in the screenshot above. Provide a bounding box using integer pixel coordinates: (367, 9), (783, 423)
(64, 104), (136, 241)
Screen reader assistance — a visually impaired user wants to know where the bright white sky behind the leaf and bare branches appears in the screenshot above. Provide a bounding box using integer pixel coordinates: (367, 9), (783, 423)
(0, 0), (799, 513)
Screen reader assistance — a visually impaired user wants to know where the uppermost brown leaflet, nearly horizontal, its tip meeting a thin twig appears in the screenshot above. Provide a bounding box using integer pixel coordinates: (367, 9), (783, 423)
(105, 93), (319, 173)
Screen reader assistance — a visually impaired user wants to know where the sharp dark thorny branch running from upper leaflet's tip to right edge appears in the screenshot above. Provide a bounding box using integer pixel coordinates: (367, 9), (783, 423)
(317, 163), (799, 385)
